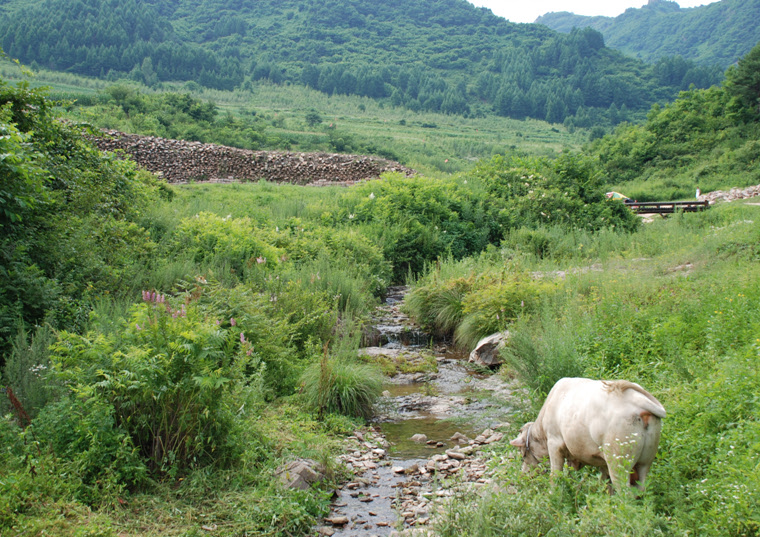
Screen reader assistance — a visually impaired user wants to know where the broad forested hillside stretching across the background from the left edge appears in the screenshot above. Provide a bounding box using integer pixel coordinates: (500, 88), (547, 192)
(0, 0), (720, 127)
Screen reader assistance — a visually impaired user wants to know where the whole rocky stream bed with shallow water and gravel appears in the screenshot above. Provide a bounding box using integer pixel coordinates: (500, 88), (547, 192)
(317, 287), (514, 537)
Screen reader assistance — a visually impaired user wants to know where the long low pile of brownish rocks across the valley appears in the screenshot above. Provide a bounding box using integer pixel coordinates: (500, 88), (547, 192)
(94, 130), (422, 186)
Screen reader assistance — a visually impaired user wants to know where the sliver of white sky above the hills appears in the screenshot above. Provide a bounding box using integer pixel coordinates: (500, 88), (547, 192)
(469, 0), (715, 22)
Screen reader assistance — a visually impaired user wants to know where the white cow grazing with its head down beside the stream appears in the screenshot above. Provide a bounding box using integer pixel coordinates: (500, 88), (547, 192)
(510, 378), (665, 490)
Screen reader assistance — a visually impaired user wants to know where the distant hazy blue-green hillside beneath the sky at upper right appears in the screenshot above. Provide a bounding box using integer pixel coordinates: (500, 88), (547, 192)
(536, 0), (760, 68)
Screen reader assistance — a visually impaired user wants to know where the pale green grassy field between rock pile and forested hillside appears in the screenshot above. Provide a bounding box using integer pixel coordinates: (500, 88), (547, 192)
(0, 62), (588, 173)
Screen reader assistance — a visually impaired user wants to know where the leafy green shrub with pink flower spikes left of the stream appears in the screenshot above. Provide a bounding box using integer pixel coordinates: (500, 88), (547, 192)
(50, 292), (260, 475)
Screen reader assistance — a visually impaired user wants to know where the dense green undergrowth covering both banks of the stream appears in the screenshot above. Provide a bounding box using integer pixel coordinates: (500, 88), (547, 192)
(0, 44), (760, 535)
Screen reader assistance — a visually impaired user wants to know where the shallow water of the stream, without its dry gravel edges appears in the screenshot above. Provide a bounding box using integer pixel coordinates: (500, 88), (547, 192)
(327, 288), (509, 537)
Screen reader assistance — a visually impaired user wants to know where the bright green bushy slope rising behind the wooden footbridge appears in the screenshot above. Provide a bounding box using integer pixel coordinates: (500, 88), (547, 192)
(590, 45), (760, 201)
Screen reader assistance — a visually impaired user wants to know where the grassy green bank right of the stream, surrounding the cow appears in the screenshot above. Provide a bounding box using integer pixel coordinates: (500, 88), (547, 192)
(407, 203), (760, 536)
